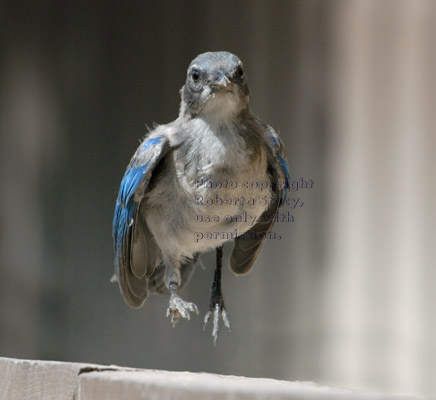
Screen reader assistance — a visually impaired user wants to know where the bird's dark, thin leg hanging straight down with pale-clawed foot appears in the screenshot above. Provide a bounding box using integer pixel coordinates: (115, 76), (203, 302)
(203, 246), (231, 345)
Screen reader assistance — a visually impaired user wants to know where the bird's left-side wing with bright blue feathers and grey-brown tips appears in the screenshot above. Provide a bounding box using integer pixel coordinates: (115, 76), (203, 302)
(112, 135), (169, 307)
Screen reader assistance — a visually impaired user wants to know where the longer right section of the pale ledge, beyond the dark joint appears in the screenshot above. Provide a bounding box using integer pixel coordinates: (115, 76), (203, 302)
(79, 370), (418, 400)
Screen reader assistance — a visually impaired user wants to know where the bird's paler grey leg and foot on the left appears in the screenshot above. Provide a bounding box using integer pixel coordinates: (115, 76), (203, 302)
(165, 263), (198, 326)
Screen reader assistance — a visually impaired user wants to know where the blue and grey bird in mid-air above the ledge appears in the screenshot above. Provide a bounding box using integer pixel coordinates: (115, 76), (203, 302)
(112, 51), (290, 344)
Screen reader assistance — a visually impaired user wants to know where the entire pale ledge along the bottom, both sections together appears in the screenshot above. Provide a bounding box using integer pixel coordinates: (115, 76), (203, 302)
(0, 358), (418, 400)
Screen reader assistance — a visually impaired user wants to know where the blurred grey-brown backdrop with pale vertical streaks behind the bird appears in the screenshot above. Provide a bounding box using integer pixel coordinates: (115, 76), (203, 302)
(0, 0), (436, 394)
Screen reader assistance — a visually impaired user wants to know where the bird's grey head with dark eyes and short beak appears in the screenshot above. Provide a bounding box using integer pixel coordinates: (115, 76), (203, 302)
(180, 51), (249, 119)
